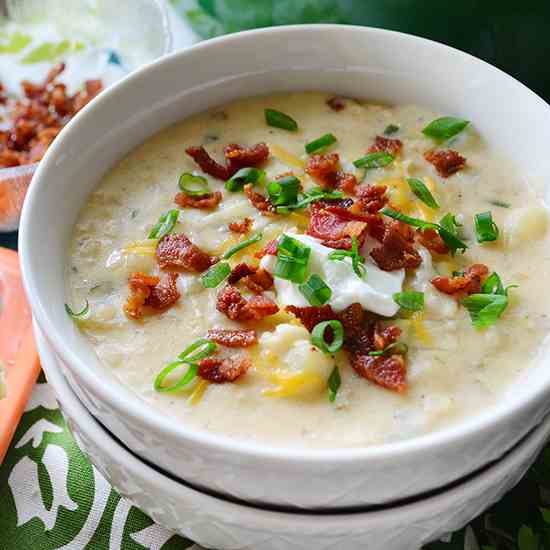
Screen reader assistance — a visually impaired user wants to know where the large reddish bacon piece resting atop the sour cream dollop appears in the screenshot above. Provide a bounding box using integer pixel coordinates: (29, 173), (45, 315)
(307, 203), (367, 248)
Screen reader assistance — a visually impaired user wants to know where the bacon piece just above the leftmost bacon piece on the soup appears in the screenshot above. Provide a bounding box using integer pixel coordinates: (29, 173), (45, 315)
(156, 233), (218, 273)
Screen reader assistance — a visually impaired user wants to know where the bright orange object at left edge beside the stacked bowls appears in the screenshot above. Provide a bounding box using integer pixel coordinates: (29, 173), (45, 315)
(0, 248), (40, 464)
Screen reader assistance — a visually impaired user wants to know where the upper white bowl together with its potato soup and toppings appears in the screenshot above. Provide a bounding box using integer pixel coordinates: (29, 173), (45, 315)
(21, 25), (550, 509)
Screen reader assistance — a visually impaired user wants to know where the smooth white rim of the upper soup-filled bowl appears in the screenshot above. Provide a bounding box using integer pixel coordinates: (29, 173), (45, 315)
(19, 24), (550, 466)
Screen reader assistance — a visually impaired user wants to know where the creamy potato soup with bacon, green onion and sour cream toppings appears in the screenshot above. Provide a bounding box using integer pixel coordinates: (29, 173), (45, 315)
(67, 93), (550, 448)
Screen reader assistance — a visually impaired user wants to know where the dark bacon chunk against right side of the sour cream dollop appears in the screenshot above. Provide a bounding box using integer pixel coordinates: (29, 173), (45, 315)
(370, 222), (422, 271)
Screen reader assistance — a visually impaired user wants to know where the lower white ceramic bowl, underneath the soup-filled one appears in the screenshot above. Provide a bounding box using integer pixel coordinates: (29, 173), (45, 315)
(37, 326), (550, 550)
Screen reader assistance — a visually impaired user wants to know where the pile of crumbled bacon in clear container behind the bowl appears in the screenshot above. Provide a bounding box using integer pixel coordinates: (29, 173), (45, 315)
(0, 63), (102, 168)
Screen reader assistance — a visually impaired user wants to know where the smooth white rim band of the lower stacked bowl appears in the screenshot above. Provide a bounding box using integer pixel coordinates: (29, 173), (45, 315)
(41, 324), (550, 528)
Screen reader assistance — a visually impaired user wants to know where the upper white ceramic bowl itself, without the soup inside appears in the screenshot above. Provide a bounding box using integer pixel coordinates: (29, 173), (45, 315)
(20, 25), (550, 508)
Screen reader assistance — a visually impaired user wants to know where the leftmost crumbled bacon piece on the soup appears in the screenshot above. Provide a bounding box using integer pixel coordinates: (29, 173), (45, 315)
(124, 272), (180, 319)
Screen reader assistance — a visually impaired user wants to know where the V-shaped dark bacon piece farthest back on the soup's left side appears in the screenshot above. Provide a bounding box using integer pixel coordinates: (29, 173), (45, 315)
(185, 143), (269, 180)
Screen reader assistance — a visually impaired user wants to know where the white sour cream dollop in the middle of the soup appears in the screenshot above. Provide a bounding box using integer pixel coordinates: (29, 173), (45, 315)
(260, 233), (405, 317)
